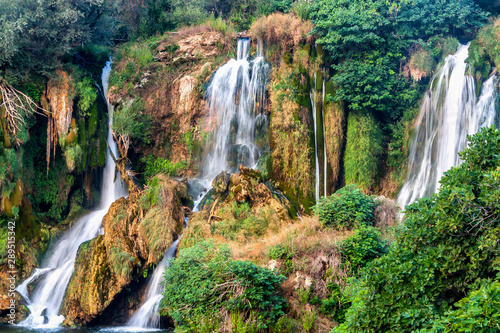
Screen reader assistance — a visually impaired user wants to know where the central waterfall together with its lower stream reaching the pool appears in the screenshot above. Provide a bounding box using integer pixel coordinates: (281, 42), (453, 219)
(127, 38), (269, 328)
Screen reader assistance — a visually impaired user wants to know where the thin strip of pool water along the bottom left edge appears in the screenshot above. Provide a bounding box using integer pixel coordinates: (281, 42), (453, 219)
(0, 325), (173, 333)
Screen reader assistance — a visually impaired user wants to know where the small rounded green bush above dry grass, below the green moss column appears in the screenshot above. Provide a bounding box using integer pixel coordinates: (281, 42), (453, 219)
(313, 185), (375, 229)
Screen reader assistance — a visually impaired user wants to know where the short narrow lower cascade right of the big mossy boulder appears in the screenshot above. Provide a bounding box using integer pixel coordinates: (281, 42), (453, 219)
(127, 238), (180, 328)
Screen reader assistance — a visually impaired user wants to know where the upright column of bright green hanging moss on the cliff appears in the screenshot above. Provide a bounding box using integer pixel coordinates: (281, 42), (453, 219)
(344, 111), (383, 191)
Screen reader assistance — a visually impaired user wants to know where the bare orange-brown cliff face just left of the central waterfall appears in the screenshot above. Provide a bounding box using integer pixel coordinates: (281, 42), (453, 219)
(108, 26), (234, 177)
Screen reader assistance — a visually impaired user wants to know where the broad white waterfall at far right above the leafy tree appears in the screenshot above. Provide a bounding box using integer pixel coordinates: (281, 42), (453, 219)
(398, 45), (496, 207)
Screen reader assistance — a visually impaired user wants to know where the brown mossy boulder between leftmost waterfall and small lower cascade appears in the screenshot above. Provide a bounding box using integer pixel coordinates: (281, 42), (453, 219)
(61, 177), (189, 326)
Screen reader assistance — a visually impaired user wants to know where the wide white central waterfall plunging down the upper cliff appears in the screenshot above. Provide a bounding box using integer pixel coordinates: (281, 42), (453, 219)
(202, 38), (269, 182)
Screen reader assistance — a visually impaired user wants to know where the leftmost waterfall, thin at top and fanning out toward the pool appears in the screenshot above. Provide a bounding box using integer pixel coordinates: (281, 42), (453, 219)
(17, 61), (127, 327)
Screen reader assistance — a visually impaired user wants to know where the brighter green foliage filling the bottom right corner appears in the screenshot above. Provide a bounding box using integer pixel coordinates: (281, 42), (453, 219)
(426, 281), (500, 333)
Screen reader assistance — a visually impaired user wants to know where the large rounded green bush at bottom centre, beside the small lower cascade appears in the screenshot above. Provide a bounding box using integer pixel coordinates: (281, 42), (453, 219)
(162, 241), (286, 332)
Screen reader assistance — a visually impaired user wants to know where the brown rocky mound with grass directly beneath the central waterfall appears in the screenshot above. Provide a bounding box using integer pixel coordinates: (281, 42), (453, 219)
(180, 165), (296, 248)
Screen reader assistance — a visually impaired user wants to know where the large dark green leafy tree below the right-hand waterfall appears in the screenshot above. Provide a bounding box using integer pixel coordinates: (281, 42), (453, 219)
(335, 128), (500, 332)
